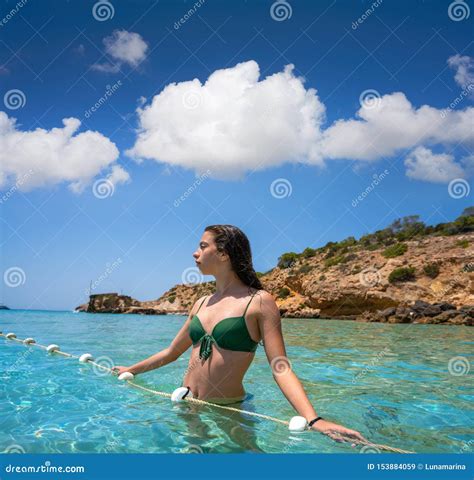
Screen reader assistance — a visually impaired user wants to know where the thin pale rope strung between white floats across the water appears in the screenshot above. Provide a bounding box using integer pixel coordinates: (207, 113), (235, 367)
(0, 332), (415, 453)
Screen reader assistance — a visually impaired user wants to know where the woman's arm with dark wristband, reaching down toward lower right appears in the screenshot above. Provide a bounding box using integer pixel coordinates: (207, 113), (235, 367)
(257, 292), (365, 440)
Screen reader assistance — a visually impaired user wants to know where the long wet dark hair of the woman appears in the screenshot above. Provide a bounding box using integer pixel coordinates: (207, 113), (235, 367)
(204, 225), (263, 290)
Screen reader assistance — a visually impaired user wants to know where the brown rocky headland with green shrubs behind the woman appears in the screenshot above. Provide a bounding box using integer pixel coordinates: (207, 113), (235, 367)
(74, 211), (474, 325)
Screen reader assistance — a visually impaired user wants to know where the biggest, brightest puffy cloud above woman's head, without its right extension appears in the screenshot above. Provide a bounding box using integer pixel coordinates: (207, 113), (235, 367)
(127, 61), (325, 179)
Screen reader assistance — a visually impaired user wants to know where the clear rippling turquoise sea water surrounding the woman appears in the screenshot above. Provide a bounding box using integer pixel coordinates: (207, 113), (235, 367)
(0, 310), (474, 453)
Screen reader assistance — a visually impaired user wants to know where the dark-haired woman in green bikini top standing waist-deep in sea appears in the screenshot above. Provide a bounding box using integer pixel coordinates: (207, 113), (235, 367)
(114, 225), (366, 441)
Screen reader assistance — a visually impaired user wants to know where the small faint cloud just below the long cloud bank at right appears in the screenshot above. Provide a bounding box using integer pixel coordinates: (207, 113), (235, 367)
(405, 147), (465, 183)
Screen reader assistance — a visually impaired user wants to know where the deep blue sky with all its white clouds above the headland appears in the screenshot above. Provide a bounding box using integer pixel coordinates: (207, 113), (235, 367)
(0, 0), (474, 309)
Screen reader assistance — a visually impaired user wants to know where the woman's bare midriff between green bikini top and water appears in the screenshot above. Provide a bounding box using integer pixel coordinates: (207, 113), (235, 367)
(183, 344), (255, 400)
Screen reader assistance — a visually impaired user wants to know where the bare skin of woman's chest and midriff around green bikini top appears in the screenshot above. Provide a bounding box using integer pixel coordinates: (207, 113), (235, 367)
(183, 295), (261, 399)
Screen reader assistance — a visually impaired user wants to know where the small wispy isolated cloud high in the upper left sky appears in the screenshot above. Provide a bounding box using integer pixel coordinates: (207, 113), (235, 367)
(92, 30), (148, 73)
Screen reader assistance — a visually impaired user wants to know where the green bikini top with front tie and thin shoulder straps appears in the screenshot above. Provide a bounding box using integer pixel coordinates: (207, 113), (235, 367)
(189, 294), (258, 361)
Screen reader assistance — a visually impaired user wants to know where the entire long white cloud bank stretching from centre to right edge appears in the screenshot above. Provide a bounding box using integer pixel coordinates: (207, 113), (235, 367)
(127, 61), (474, 181)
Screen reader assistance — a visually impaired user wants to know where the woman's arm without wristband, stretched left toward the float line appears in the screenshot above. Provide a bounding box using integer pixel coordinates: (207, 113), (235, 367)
(112, 299), (201, 375)
